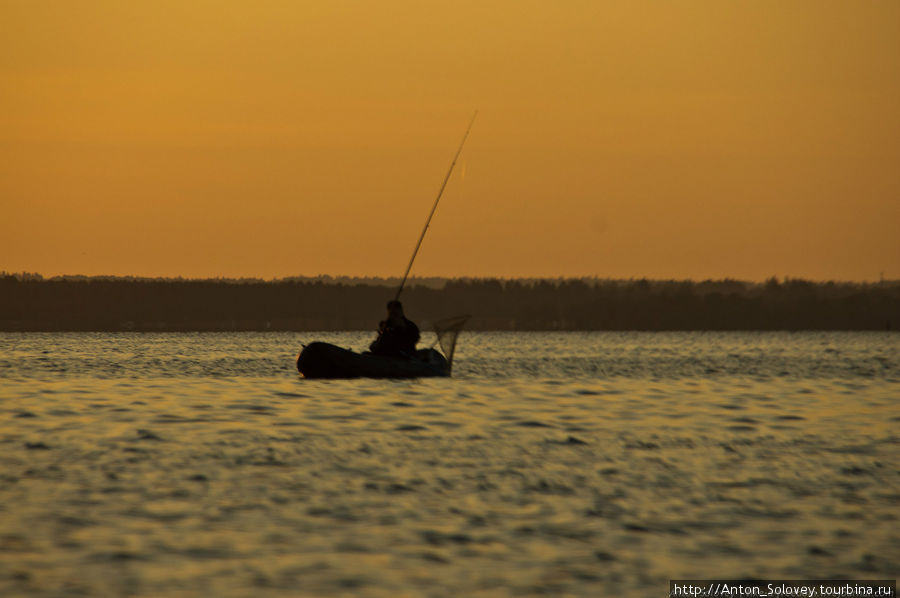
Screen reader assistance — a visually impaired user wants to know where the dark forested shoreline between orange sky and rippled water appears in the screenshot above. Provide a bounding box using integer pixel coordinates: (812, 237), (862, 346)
(0, 273), (900, 331)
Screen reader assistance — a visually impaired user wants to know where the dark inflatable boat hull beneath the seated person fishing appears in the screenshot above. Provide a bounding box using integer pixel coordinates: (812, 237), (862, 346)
(297, 342), (450, 378)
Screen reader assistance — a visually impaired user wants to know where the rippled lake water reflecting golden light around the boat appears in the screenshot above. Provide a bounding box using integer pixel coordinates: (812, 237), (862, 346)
(0, 333), (900, 598)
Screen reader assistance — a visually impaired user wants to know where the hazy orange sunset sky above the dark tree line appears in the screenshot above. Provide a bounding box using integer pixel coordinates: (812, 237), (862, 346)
(0, 0), (900, 280)
